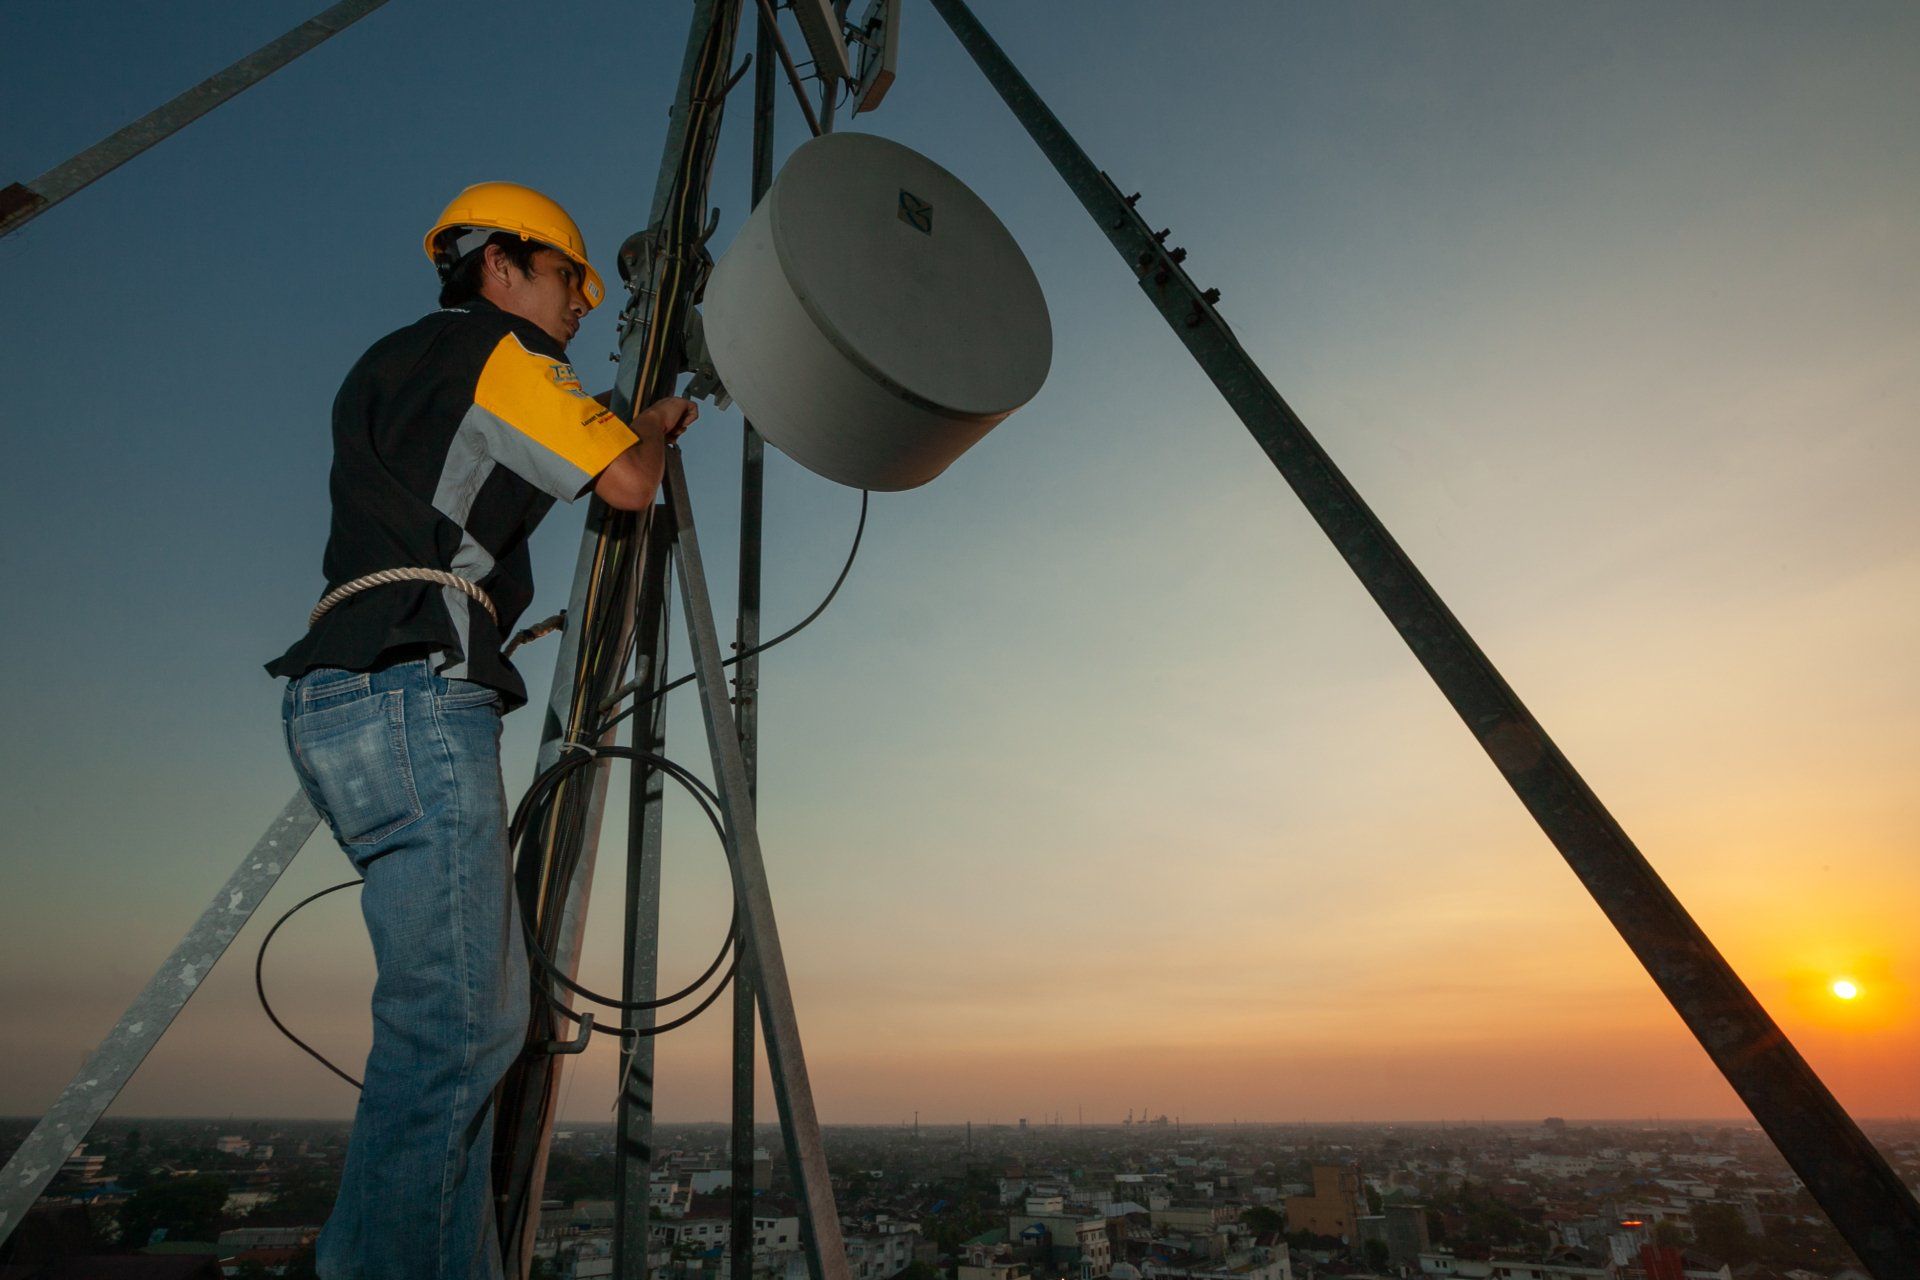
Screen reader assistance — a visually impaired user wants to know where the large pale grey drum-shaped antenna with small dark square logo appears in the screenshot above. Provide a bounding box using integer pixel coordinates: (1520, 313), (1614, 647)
(705, 132), (1054, 489)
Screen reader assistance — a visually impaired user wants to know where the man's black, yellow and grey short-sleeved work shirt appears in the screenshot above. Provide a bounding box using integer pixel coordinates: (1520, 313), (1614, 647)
(267, 299), (634, 708)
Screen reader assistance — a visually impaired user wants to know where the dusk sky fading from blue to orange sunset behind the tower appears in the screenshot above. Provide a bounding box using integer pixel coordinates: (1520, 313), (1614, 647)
(0, 0), (1920, 1123)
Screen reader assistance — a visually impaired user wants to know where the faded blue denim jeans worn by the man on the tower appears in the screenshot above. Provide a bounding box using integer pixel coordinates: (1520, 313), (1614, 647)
(282, 658), (528, 1280)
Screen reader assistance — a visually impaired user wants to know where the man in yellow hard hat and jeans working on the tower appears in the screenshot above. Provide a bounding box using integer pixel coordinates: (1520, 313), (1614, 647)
(267, 182), (699, 1280)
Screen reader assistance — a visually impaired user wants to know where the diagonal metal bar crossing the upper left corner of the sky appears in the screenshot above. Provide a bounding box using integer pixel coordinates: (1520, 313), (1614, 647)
(0, 0), (386, 236)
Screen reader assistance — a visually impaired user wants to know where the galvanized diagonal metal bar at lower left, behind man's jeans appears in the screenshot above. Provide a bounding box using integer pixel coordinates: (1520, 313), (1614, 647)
(0, 791), (321, 1244)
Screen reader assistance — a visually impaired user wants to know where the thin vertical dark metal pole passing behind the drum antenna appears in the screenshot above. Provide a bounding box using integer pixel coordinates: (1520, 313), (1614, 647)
(728, 8), (776, 1280)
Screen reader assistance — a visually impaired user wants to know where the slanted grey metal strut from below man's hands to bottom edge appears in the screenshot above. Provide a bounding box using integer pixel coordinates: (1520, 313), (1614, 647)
(666, 447), (849, 1280)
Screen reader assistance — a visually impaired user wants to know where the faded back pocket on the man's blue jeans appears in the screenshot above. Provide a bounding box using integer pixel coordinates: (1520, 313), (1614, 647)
(288, 689), (420, 844)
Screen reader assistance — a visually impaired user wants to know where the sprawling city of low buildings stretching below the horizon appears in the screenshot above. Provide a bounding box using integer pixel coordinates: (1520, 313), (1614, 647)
(11, 1119), (1889, 1280)
